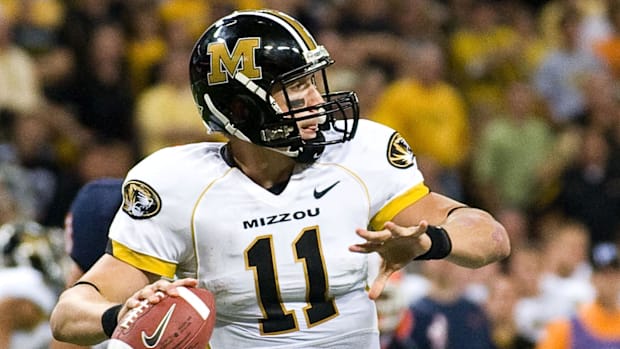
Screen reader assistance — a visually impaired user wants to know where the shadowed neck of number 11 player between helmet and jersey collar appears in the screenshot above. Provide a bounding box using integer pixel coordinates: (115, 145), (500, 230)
(228, 140), (295, 188)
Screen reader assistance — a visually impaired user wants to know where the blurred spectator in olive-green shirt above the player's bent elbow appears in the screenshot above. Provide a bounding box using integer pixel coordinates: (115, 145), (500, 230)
(472, 81), (555, 212)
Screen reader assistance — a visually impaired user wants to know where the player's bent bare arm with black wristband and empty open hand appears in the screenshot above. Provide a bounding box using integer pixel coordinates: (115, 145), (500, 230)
(349, 192), (510, 299)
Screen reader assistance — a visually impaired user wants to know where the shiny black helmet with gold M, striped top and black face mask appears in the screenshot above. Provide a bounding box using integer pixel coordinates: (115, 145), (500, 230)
(190, 10), (359, 162)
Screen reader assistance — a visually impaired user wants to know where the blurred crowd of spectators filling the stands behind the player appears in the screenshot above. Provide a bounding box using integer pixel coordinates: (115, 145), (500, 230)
(0, 0), (620, 349)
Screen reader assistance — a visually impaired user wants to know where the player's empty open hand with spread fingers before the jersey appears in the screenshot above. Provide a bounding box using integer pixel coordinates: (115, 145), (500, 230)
(349, 221), (431, 299)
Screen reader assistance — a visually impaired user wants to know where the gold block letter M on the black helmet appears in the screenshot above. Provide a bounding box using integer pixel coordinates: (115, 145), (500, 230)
(207, 38), (262, 85)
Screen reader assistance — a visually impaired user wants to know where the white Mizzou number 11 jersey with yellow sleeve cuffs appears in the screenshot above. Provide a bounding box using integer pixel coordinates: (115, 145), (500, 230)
(110, 120), (428, 349)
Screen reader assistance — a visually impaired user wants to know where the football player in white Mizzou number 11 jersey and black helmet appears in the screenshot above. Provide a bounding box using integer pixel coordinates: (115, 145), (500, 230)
(51, 10), (510, 349)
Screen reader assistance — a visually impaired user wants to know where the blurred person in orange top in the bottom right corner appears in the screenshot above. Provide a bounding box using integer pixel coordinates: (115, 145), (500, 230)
(536, 243), (620, 349)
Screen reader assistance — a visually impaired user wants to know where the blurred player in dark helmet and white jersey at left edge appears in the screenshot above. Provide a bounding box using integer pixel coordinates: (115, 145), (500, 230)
(0, 221), (63, 349)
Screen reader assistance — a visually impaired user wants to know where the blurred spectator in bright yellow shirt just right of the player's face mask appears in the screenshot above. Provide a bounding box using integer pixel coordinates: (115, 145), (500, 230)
(370, 42), (470, 198)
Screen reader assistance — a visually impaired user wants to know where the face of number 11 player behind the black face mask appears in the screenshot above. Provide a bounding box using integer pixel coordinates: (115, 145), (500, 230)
(273, 75), (324, 139)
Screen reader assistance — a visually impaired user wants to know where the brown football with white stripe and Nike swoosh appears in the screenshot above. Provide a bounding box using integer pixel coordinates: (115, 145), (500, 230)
(108, 287), (215, 349)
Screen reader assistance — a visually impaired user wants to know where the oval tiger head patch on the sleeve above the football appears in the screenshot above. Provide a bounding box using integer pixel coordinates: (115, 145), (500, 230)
(123, 180), (161, 219)
